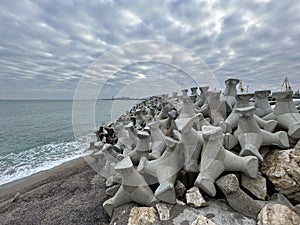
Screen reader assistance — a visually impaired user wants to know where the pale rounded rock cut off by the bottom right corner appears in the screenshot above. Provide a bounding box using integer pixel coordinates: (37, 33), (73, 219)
(257, 204), (300, 225)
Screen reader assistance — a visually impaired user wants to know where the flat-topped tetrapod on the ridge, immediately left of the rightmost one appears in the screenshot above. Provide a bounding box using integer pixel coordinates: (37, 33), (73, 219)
(254, 90), (273, 117)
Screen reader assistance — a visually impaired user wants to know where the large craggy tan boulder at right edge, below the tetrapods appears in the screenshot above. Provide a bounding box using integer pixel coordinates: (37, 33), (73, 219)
(261, 149), (300, 203)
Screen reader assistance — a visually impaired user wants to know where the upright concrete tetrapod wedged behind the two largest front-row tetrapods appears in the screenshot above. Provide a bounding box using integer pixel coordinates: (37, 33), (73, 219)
(173, 113), (203, 173)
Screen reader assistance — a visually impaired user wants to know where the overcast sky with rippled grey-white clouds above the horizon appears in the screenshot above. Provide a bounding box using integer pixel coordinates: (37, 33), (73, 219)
(0, 0), (300, 99)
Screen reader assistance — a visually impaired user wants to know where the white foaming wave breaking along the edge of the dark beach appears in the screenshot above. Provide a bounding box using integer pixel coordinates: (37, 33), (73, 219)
(0, 140), (89, 185)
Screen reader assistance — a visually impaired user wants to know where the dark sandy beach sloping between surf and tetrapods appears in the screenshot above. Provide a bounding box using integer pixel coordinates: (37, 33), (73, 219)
(0, 158), (109, 225)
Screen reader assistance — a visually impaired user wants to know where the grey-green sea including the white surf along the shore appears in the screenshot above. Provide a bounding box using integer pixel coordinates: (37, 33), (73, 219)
(0, 100), (136, 185)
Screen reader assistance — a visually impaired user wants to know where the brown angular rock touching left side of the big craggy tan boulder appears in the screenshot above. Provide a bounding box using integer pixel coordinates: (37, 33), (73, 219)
(241, 174), (267, 200)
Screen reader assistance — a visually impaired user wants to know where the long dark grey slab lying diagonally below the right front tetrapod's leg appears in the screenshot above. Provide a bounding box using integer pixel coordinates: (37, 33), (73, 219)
(216, 174), (265, 219)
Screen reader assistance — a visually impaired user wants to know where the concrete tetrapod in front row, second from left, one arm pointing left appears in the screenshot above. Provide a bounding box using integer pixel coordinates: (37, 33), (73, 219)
(137, 137), (184, 204)
